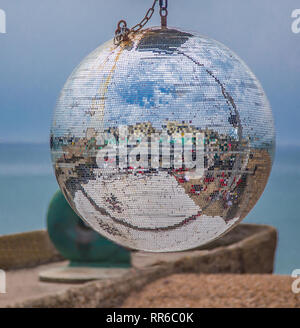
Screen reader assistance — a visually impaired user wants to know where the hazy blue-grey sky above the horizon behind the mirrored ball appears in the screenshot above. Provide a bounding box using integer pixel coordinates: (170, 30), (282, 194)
(0, 0), (300, 145)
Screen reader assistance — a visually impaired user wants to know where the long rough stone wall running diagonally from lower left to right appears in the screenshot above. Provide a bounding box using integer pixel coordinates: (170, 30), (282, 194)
(2, 225), (277, 308)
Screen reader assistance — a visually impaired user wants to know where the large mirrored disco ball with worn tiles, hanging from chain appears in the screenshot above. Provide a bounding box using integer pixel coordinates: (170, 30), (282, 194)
(51, 28), (275, 252)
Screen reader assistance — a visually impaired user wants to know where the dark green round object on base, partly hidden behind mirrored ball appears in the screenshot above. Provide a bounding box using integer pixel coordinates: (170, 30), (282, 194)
(47, 190), (130, 267)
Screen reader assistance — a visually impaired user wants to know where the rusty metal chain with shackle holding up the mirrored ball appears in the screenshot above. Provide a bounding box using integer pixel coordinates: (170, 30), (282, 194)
(114, 0), (168, 45)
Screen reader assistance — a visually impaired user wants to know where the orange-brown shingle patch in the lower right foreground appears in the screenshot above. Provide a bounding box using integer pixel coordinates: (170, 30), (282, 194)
(122, 273), (300, 309)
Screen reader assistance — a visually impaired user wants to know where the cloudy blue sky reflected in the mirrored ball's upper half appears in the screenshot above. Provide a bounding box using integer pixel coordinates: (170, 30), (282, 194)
(53, 28), (274, 150)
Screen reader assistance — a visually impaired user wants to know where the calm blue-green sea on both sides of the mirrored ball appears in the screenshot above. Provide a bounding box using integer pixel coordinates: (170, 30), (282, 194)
(0, 143), (300, 274)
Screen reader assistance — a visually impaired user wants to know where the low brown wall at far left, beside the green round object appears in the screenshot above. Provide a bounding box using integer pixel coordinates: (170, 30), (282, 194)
(0, 230), (63, 270)
